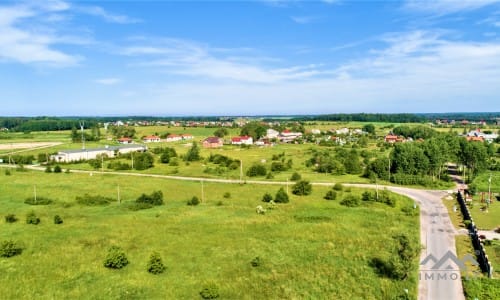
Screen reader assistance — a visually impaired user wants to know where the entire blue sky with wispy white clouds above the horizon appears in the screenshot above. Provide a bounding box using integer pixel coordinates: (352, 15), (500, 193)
(0, 0), (500, 116)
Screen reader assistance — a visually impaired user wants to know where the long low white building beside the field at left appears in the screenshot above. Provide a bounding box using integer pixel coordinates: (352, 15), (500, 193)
(50, 145), (148, 162)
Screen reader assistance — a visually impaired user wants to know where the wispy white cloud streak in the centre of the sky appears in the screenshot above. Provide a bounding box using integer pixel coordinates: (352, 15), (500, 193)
(121, 39), (324, 84)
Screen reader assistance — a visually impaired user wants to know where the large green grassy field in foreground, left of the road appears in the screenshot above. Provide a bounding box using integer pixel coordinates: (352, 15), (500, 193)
(0, 169), (419, 299)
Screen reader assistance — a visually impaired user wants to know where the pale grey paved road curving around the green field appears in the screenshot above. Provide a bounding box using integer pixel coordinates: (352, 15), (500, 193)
(0, 166), (465, 300)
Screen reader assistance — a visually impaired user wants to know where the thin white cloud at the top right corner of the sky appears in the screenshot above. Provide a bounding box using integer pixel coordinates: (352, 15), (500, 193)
(404, 0), (500, 15)
